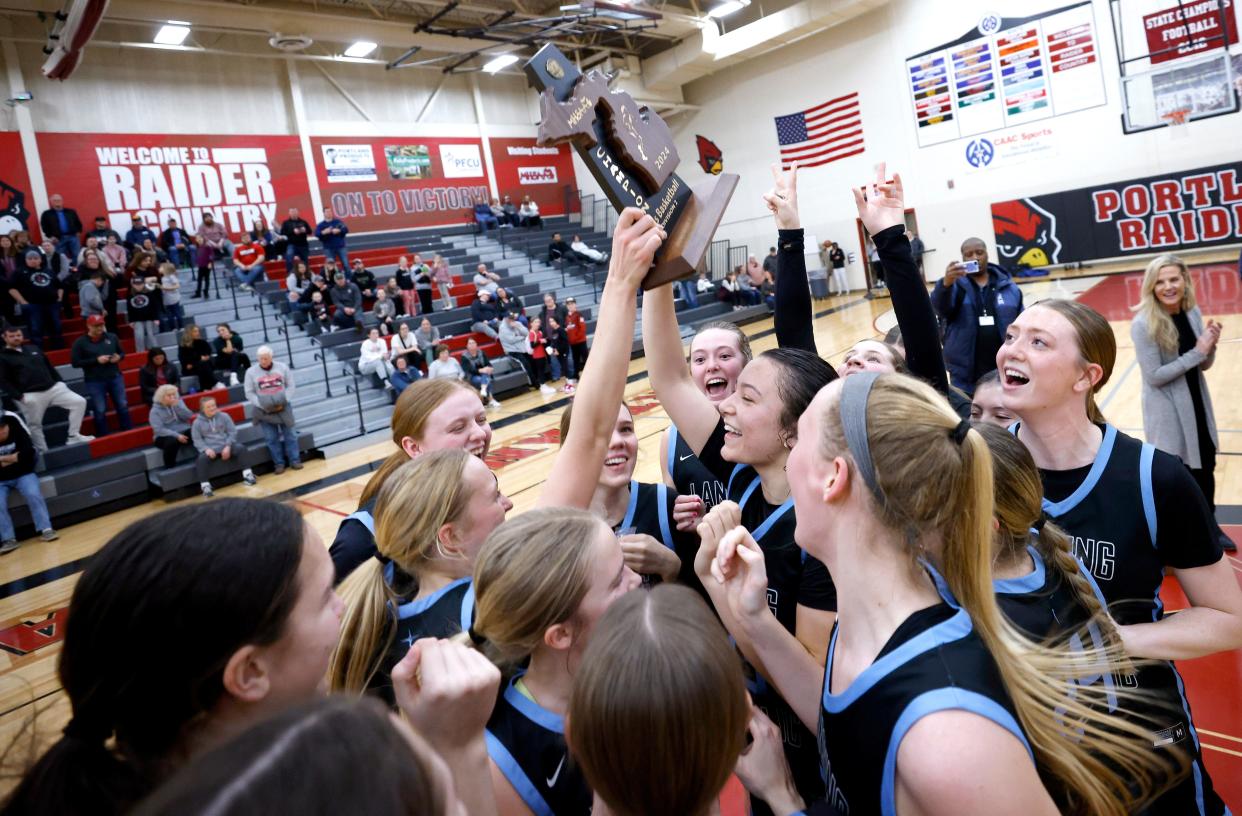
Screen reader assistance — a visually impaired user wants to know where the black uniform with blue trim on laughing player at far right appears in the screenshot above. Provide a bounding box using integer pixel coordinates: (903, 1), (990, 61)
(1013, 425), (1227, 816)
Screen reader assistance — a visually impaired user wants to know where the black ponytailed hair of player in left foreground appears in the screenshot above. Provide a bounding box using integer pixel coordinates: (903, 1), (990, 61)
(2, 499), (304, 816)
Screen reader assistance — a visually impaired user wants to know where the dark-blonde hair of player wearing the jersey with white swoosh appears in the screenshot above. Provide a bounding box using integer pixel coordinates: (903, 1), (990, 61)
(474, 507), (607, 664)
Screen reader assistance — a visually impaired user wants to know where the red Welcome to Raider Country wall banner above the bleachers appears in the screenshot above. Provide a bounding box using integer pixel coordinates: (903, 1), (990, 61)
(37, 133), (311, 235)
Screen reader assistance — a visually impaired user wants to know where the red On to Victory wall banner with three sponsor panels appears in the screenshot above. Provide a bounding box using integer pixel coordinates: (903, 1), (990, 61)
(311, 135), (491, 232)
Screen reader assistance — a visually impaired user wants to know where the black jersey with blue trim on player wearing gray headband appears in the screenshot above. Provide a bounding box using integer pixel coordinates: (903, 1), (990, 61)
(820, 602), (1033, 816)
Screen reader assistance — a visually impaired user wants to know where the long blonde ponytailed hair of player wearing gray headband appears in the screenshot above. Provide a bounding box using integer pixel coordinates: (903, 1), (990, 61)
(820, 374), (1176, 816)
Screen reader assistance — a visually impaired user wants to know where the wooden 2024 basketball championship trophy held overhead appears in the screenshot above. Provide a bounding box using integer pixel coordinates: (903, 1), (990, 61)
(525, 45), (738, 289)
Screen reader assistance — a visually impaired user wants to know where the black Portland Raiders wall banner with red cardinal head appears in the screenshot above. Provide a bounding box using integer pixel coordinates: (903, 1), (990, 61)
(992, 163), (1242, 267)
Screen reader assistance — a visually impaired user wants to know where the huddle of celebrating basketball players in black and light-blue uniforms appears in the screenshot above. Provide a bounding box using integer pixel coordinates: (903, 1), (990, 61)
(2, 166), (1242, 816)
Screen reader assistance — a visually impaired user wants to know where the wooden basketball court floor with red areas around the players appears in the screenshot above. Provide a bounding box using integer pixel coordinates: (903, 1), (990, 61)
(0, 262), (1242, 812)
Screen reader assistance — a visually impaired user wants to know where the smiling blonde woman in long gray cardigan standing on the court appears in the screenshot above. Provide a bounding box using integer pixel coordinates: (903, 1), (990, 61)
(1130, 255), (1221, 510)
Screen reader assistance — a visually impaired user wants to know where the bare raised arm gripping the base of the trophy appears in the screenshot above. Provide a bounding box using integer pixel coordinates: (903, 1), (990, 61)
(538, 207), (665, 509)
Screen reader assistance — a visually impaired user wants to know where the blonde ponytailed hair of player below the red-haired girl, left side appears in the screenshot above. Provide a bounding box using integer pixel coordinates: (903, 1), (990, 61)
(328, 448), (471, 693)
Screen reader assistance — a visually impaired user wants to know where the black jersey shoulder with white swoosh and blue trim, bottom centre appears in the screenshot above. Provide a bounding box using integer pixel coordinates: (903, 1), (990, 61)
(483, 676), (594, 816)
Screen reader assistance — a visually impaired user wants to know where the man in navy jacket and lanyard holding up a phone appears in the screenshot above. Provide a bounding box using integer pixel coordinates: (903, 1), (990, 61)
(932, 238), (1022, 394)
